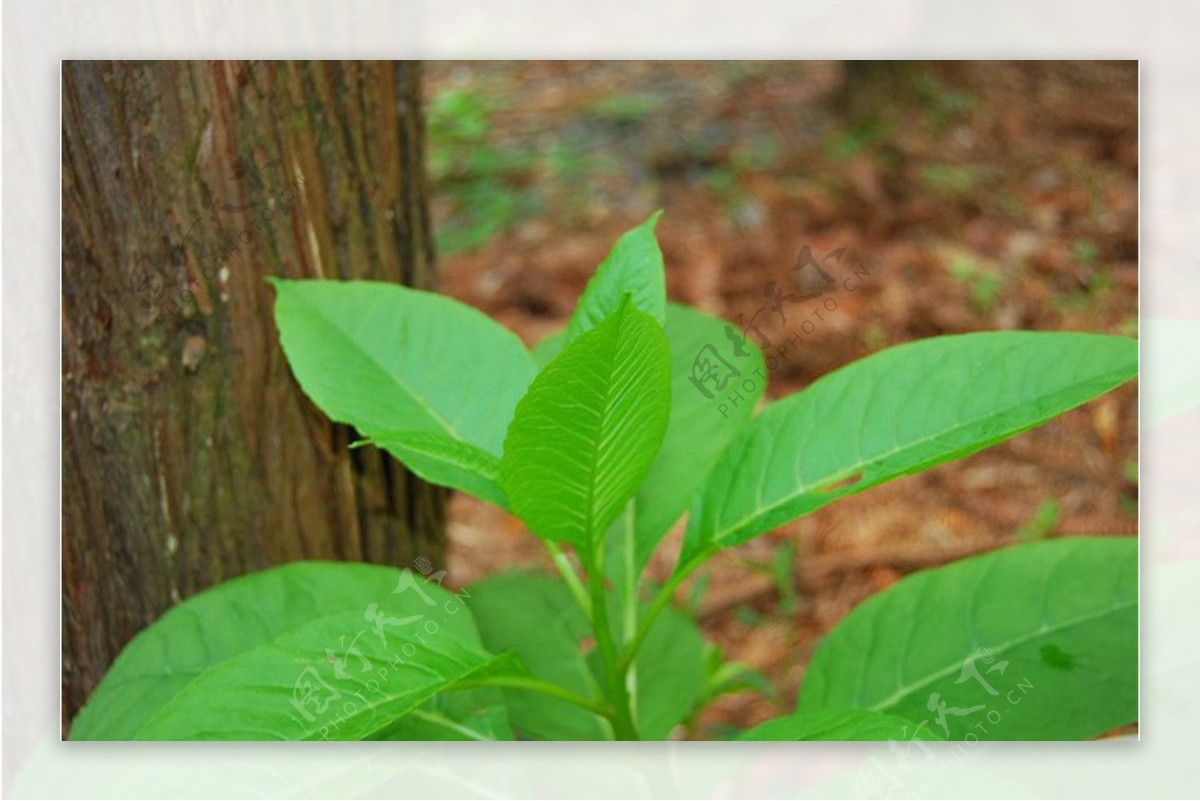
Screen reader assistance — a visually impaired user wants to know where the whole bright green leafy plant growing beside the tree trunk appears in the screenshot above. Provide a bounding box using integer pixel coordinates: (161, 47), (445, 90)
(71, 214), (1138, 741)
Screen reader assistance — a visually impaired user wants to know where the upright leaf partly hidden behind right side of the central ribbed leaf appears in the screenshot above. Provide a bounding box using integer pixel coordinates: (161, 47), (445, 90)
(634, 303), (767, 574)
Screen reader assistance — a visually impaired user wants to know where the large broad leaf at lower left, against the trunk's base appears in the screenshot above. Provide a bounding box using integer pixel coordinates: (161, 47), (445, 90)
(71, 562), (506, 740)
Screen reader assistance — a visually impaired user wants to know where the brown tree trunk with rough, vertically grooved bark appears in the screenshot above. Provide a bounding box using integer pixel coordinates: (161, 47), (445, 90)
(62, 62), (443, 721)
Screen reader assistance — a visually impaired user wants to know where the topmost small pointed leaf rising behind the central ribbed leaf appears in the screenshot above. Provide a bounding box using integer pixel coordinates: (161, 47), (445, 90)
(566, 211), (667, 342)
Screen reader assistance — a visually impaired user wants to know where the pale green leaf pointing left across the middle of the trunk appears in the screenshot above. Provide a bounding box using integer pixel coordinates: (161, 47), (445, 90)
(272, 279), (536, 456)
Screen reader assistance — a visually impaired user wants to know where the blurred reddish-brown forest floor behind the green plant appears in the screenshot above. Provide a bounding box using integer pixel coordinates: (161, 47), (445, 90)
(426, 62), (1138, 739)
